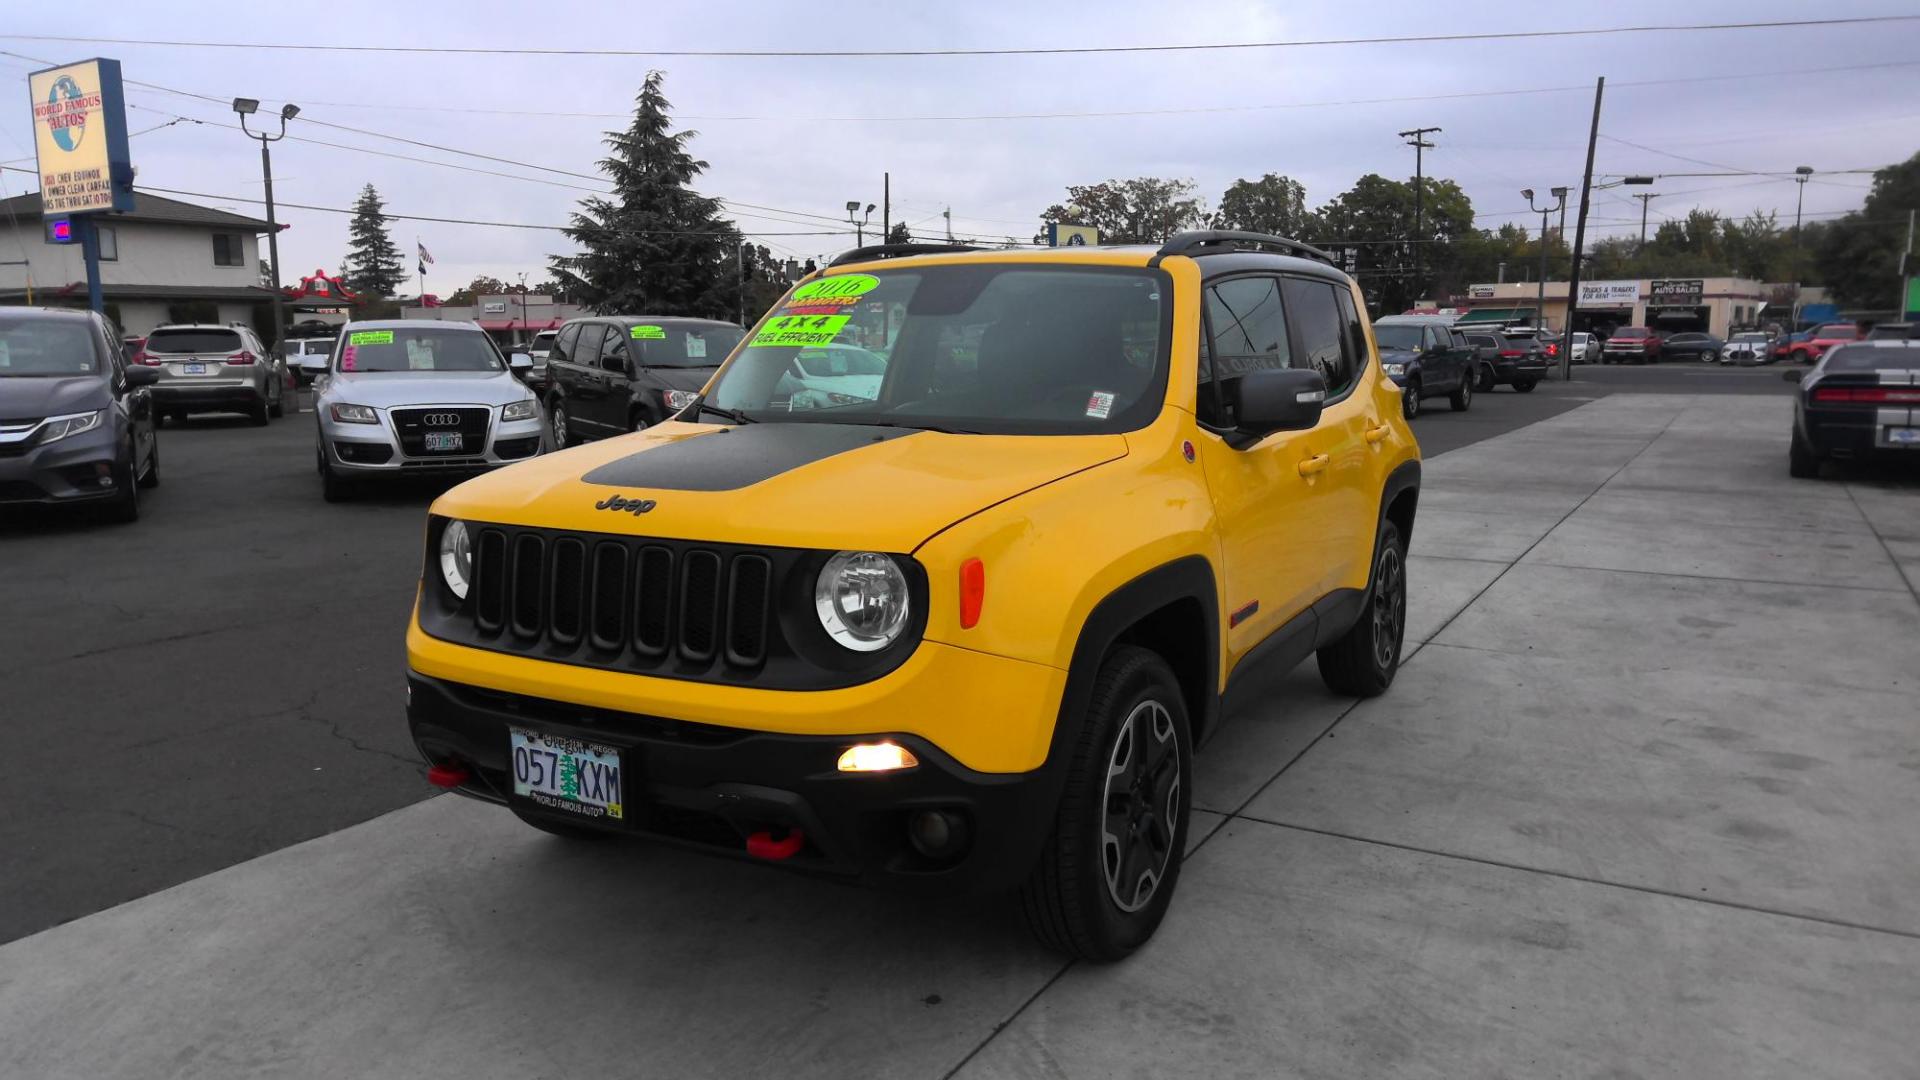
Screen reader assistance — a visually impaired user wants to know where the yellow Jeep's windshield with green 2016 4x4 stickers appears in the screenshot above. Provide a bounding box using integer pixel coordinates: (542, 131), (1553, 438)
(710, 265), (1171, 434)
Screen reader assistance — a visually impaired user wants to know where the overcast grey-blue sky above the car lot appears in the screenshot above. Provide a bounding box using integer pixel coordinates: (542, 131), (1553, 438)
(0, 0), (1920, 294)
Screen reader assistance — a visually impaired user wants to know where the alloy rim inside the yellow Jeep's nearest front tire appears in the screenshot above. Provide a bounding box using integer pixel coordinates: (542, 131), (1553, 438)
(1100, 698), (1181, 913)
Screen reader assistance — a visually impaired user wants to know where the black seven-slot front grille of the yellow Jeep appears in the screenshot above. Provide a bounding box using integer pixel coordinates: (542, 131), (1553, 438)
(420, 519), (925, 690)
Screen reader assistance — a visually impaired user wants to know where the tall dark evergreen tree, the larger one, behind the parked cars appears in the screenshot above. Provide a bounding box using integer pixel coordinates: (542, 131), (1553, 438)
(551, 71), (741, 319)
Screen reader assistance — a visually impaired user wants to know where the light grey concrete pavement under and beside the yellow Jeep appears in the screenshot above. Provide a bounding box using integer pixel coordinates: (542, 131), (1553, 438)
(0, 394), (1920, 1078)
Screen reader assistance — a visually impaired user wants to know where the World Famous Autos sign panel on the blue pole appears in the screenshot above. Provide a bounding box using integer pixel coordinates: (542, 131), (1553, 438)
(27, 60), (132, 215)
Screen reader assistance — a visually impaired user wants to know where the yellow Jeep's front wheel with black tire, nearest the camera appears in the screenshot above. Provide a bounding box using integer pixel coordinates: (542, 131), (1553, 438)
(1020, 646), (1192, 963)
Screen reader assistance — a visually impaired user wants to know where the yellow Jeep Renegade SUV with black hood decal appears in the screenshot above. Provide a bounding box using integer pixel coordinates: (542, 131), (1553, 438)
(407, 233), (1419, 959)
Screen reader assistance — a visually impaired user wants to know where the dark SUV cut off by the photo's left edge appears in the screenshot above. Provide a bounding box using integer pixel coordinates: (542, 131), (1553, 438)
(0, 307), (159, 521)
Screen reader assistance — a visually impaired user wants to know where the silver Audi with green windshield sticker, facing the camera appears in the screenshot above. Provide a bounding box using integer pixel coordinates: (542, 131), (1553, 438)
(313, 319), (545, 502)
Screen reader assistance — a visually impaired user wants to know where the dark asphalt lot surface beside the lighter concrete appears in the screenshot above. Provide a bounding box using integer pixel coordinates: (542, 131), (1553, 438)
(0, 365), (1786, 942)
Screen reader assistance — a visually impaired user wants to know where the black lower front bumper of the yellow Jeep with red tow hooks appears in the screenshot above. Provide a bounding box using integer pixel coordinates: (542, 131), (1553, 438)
(407, 671), (1060, 894)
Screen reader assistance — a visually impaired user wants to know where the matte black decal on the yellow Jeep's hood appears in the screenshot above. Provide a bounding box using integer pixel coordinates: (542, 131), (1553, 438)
(580, 423), (916, 492)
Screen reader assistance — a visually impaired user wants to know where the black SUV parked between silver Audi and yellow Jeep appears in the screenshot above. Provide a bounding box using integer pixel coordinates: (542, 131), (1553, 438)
(547, 315), (745, 450)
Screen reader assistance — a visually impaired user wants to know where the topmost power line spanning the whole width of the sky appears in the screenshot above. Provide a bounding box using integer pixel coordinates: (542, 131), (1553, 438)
(0, 15), (1920, 60)
